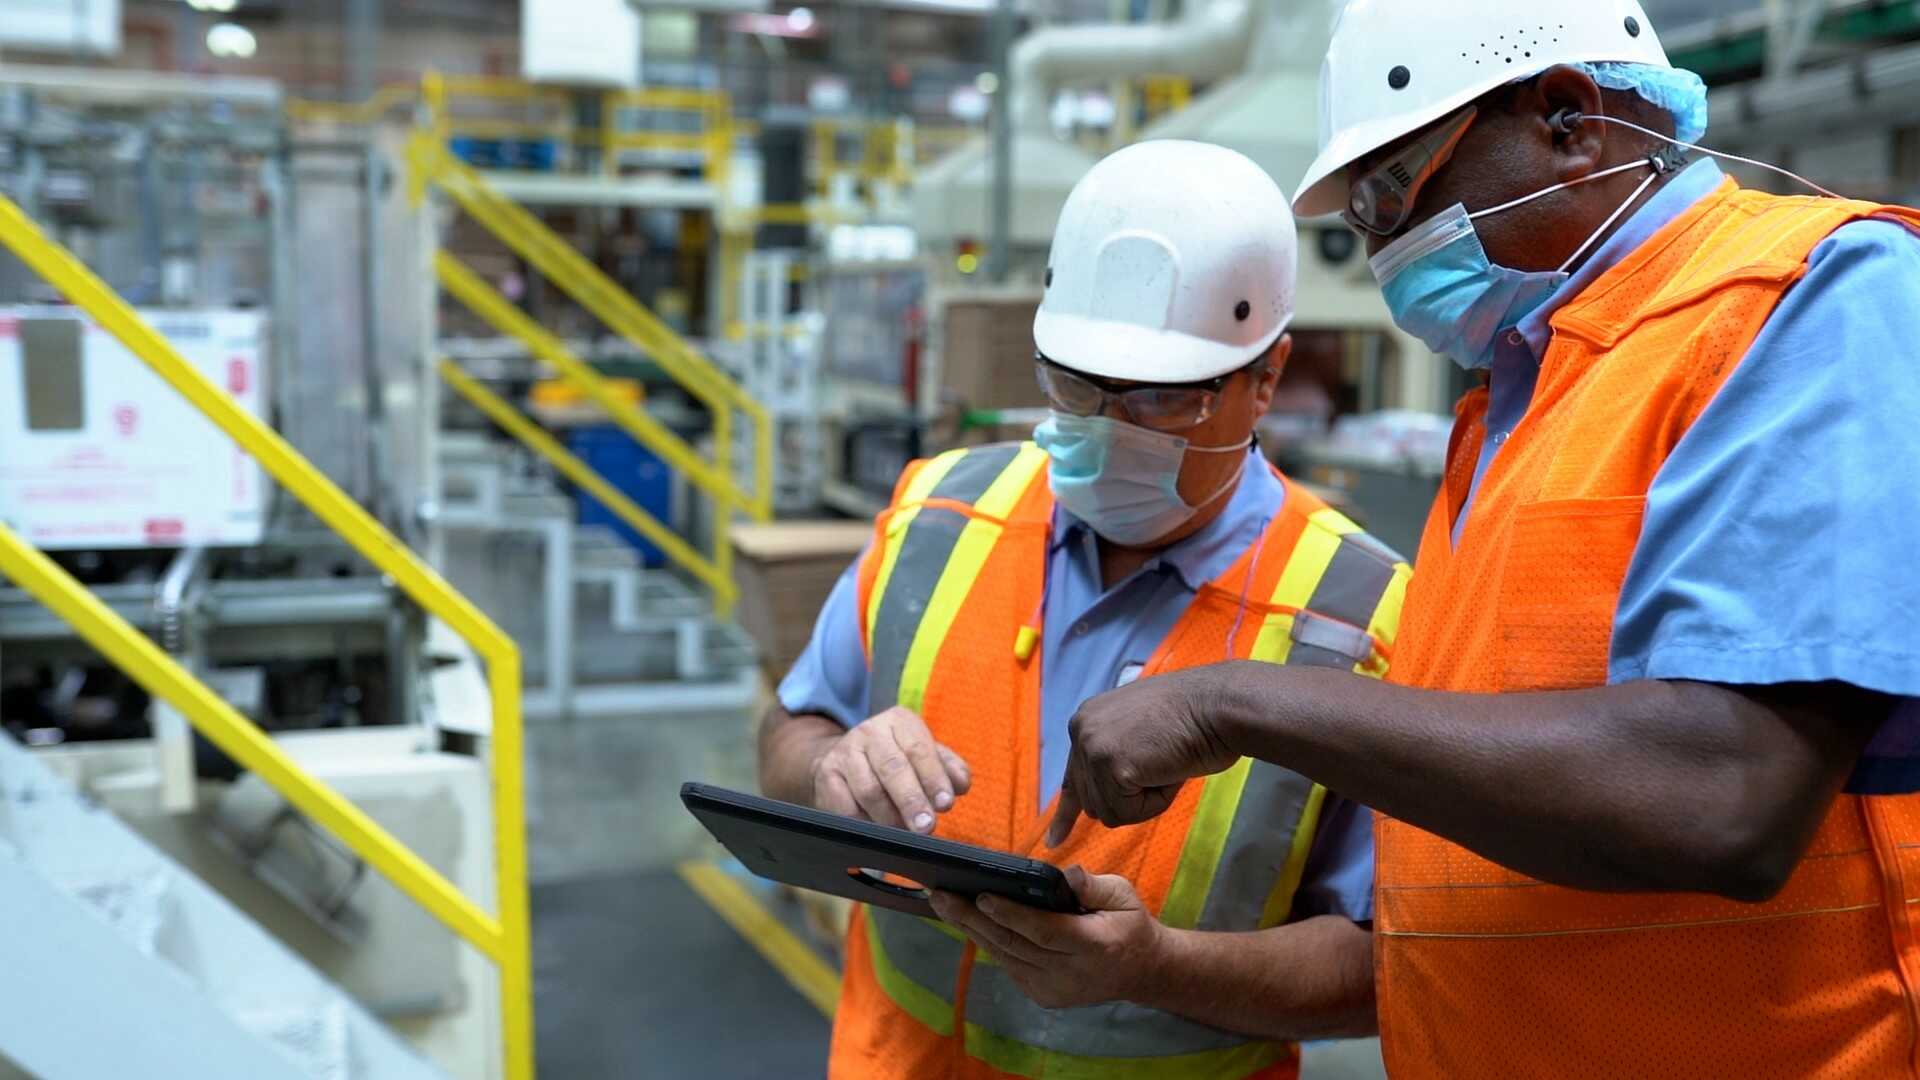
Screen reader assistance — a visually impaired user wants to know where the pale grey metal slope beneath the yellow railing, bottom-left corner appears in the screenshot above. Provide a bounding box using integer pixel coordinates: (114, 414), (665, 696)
(0, 734), (442, 1080)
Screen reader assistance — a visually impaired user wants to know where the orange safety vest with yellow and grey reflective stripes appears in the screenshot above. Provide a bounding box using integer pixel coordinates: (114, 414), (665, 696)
(831, 444), (1411, 1080)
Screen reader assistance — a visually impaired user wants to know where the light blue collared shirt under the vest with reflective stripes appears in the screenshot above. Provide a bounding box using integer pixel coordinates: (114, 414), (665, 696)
(780, 452), (1373, 922)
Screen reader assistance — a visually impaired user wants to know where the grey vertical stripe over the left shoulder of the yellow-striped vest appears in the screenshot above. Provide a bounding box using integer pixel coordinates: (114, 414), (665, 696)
(866, 442), (1020, 713)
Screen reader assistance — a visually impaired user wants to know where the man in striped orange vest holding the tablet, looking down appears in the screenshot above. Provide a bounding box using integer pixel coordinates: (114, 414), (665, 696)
(760, 140), (1411, 1080)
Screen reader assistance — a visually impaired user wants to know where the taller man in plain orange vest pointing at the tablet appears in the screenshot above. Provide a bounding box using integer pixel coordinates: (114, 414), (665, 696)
(1058, 0), (1920, 1080)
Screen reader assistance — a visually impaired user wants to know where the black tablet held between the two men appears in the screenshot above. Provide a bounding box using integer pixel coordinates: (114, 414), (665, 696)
(680, 784), (1081, 919)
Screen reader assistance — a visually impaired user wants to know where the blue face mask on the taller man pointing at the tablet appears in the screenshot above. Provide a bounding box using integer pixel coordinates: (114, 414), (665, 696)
(1367, 153), (1663, 371)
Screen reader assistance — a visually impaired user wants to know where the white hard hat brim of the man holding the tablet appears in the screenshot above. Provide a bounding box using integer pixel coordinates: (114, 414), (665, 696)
(1033, 309), (1286, 384)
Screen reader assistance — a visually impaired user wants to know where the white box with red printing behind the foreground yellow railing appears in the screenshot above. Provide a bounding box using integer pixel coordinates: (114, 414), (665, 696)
(0, 307), (269, 550)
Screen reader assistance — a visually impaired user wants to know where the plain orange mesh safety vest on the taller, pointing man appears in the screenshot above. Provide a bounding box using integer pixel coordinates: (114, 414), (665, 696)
(1375, 183), (1920, 1080)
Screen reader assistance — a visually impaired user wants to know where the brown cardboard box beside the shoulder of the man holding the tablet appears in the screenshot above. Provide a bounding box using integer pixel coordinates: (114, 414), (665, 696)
(732, 521), (874, 680)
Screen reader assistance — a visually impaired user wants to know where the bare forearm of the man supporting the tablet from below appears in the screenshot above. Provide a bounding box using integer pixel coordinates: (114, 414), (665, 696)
(1137, 915), (1379, 1042)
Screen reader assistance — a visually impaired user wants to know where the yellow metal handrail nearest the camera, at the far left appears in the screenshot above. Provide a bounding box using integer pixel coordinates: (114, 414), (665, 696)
(0, 196), (534, 1080)
